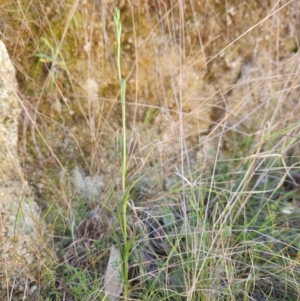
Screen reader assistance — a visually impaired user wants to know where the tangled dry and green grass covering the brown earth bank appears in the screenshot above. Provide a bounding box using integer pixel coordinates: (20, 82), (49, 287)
(0, 0), (300, 300)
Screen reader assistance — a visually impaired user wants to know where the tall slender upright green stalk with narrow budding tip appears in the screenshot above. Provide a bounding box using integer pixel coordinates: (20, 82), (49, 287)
(113, 8), (130, 300)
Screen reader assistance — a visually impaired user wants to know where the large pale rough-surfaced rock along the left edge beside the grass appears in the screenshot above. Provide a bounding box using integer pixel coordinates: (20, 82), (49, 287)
(0, 41), (44, 300)
